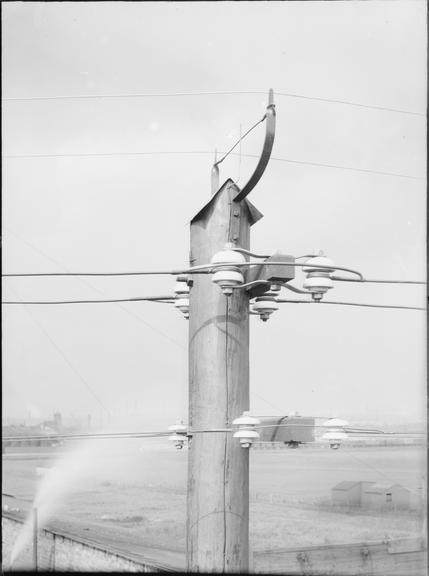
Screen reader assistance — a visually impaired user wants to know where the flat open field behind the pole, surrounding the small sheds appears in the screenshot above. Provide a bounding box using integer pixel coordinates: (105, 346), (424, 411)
(3, 440), (425, 565)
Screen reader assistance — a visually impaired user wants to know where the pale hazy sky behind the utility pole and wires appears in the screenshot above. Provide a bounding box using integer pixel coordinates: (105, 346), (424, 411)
(2, 0), (427, 429)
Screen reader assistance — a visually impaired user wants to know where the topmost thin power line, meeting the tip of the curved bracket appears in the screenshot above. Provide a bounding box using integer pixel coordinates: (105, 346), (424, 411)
(2, 90), (426, 117)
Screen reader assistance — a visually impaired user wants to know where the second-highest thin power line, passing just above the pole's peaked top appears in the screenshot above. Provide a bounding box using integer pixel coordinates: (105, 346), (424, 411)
(3, 150), (424, 180)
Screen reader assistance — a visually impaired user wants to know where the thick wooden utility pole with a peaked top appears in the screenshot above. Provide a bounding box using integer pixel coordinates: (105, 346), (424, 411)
(187, 180), (261, 573)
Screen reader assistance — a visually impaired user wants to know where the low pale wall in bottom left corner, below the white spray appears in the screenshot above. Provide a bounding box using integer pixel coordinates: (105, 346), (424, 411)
(2, 513), (173, 572)
